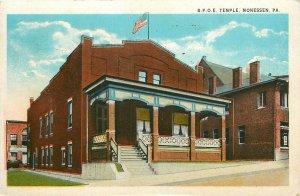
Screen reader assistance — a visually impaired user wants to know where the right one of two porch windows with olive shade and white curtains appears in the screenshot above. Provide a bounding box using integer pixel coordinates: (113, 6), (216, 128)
(173, 113), (189, 137)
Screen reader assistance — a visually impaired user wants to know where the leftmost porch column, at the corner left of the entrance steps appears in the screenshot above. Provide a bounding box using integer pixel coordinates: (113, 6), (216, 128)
(106, 100), (116, 161)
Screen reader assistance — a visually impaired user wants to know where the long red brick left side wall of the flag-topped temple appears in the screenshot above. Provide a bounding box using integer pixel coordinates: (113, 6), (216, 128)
(28, 44), (85, 172)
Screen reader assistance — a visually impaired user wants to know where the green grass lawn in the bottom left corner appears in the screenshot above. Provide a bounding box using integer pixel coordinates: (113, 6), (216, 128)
(7, 170), (82, 186)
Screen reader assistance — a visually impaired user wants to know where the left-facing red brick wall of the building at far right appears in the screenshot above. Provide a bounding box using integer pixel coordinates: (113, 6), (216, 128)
(226, 84), (275, 159)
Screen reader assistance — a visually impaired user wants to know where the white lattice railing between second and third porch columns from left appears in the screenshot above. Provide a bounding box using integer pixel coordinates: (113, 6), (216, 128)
(158, 136), (190, 147)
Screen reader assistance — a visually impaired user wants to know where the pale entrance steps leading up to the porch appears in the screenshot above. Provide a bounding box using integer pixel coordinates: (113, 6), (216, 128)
(119, 146), (154, 176)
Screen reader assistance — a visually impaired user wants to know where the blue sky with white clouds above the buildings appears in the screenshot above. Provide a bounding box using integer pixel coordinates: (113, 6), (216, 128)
(6, 13), (289, 120)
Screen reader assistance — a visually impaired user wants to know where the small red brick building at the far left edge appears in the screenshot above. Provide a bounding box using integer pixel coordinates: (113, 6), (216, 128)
(6, 120), (27, 165)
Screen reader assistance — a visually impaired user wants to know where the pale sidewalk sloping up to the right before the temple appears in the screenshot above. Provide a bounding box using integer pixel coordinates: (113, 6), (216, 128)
(88, 160), (289, 186)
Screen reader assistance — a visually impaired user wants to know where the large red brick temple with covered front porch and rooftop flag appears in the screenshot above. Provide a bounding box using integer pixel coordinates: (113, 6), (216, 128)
(28, 37), (230, 178)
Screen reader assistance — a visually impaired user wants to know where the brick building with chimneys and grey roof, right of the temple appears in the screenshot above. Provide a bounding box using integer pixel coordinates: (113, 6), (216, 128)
(200, 57), (289, 160)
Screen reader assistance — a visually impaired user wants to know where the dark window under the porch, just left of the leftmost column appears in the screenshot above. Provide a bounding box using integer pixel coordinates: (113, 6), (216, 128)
(96, 105), (108, 133)
